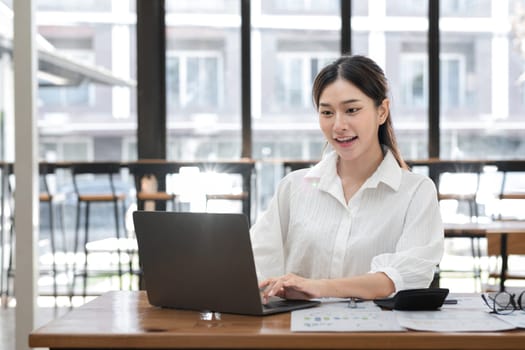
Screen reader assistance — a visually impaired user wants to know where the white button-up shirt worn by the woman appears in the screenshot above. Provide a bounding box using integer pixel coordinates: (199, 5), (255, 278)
(250, 151), (444, 291)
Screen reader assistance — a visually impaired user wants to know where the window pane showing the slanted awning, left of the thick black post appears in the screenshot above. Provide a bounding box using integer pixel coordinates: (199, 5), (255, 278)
(36, 0), (137, 161)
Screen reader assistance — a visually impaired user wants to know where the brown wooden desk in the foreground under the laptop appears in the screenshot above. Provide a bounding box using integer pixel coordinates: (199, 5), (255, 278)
(29, 291), (525, 350)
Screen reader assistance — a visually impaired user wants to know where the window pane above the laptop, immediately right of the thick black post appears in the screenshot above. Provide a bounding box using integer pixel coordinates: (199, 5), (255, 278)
(166, 0), (241, 160)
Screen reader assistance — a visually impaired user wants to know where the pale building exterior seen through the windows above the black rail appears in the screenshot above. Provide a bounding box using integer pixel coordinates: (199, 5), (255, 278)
(0, 0), (525, 217)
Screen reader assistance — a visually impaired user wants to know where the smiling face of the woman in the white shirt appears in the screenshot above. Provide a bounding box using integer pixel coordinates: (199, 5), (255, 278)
(318, 78), (389, 160)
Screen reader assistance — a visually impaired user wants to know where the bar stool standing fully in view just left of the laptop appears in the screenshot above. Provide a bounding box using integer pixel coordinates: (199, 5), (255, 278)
(70, 162), (132, 299)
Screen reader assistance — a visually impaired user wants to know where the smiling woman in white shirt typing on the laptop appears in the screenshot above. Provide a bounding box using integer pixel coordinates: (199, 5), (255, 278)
(251, 56), (444, 301)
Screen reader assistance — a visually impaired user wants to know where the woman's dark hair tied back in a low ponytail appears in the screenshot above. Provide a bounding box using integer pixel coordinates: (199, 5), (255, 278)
(312, 55), (408, 169)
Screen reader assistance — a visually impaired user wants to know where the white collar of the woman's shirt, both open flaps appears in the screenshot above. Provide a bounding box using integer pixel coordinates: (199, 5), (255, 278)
(304, 147), (402, 192)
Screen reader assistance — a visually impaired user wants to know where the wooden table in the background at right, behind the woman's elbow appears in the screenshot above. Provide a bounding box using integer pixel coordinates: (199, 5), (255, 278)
(445, 221), (525, 290)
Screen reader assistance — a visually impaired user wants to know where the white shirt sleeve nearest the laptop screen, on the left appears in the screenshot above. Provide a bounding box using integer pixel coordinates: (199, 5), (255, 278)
(250, 177), (290, 282)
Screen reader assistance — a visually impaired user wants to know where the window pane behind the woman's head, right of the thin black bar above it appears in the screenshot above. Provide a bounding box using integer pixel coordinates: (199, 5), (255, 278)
(351, 0), (428, 159)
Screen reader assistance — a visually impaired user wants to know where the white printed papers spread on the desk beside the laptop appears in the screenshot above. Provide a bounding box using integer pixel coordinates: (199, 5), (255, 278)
(291, 295), (525, 332)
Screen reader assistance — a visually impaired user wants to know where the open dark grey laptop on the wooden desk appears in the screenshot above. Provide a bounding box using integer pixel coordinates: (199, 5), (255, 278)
(133, 211), (320, 316)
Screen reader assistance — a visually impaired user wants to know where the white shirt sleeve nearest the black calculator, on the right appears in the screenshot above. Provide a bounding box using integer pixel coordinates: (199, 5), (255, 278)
(371, 179), (444, 292)
